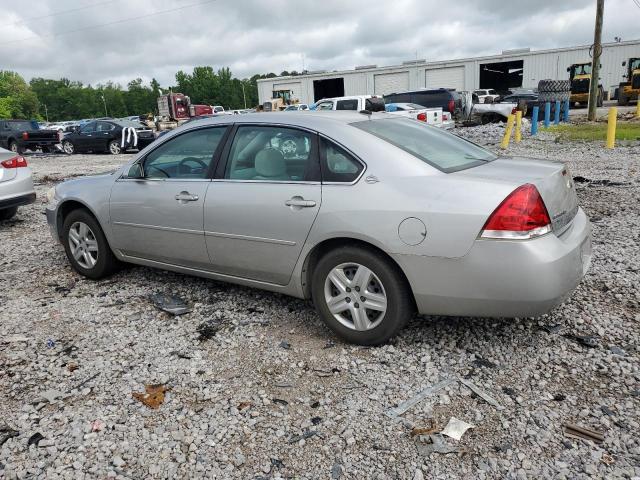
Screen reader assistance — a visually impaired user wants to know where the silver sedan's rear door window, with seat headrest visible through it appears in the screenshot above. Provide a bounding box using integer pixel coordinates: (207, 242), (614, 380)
(224, 125), (316, 182)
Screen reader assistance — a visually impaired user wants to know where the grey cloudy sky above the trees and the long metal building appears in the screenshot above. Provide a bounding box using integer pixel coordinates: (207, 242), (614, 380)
(0, 0), (640, 85)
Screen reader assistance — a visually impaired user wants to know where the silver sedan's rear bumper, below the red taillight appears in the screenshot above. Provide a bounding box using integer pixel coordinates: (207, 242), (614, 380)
(393, 209), (591, 318)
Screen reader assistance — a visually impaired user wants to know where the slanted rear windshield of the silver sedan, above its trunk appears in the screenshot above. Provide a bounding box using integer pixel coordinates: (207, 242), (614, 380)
(352, 118), (498, 173)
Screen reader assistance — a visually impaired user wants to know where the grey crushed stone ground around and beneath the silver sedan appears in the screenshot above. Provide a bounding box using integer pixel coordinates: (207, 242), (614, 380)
(0, 125), (640, 480)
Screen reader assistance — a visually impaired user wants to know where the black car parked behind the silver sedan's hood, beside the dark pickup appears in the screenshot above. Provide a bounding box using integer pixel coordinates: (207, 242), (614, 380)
(62, 120), (155, 155)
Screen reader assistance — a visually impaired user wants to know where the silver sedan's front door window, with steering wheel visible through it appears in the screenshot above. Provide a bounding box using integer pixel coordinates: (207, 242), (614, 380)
(144, 127), (227, 179)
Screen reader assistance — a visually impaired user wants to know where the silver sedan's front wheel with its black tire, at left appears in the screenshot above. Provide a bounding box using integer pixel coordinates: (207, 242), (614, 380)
(62, 209), (118, 280)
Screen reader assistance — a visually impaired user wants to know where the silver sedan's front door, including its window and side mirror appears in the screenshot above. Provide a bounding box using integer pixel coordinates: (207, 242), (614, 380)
(110, 126), (227, 268)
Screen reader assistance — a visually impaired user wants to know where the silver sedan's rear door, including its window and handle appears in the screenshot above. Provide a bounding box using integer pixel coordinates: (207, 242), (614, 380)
(204, 125), (322, 285)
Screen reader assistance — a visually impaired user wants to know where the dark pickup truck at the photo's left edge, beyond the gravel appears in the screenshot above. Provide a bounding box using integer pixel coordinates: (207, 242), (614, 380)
(0, 120), (60, 153)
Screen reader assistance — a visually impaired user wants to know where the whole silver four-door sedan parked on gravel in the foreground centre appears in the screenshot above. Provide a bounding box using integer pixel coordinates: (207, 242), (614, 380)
(47, 112), (591, 345)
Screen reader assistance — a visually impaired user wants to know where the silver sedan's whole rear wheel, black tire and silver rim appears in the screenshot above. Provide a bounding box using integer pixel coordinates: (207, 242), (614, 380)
(311, 246), (414, 345)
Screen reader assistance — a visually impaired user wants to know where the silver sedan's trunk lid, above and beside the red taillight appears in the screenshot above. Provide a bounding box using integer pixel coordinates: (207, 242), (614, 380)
(455, 157), (578, 235)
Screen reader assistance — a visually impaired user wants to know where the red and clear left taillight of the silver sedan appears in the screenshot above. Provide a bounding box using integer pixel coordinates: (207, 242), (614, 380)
(480, 183), (551, 239)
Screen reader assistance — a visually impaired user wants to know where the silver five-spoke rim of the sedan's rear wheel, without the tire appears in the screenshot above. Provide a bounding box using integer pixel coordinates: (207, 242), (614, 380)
(324, 263), (387, 331)
